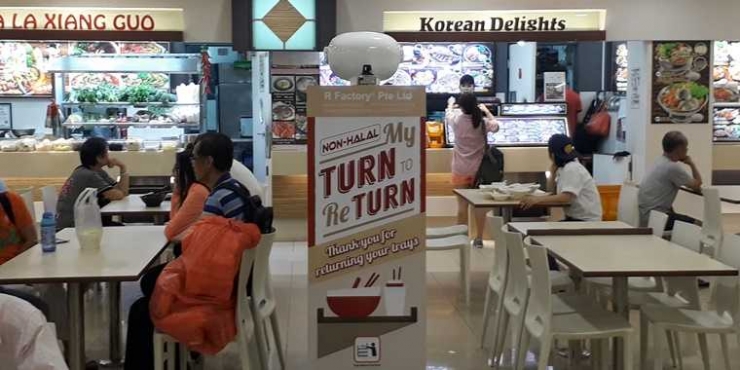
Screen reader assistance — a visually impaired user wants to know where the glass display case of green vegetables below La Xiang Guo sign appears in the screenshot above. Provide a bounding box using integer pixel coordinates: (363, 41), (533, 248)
(49, 54), (206, 139)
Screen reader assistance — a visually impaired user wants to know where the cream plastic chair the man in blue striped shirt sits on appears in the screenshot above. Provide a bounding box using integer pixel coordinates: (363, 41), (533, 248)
(153, 240), (264, 370)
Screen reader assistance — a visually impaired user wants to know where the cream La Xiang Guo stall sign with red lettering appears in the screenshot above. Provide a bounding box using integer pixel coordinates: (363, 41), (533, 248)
(0, 7), (184, 31)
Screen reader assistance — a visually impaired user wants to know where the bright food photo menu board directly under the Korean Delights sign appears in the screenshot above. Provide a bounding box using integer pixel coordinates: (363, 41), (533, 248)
(321, 43), (494, 94)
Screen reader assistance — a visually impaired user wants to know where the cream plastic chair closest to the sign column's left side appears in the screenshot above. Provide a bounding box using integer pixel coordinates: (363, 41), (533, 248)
(251, 232), (286, 369)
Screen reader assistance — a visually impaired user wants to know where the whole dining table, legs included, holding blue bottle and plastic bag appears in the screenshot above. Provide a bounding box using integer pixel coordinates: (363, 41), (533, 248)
(0, 226), (167, 370)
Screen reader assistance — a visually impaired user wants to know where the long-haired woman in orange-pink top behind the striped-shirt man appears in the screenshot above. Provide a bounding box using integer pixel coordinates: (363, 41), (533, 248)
(164, 148), (210, 241)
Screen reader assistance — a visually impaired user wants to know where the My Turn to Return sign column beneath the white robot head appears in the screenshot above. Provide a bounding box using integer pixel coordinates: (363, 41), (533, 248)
(308, 86), (426, 370)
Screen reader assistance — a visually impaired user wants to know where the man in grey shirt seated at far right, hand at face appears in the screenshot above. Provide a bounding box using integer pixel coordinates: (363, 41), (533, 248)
(637, 131), (702, 230)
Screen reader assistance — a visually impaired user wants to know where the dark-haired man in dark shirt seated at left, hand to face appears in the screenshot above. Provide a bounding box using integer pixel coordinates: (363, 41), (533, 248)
(57, 137), (129, 229)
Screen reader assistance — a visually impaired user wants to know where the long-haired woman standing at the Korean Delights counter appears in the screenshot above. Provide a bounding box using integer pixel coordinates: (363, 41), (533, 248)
(445, 93), (499, 248)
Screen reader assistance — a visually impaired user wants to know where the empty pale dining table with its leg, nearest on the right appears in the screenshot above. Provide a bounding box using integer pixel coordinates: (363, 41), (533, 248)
(528, 231), (738, 369)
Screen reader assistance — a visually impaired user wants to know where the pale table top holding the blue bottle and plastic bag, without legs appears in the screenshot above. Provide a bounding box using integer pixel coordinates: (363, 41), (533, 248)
(0, 226), (167, 284)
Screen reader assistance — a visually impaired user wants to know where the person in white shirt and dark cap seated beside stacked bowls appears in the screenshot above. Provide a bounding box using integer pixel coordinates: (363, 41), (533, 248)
(522, 134), (602, 221)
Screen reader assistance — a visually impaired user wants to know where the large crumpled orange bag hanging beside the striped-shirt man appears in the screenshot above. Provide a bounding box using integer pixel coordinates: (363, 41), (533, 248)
(149, 217), (261, 355)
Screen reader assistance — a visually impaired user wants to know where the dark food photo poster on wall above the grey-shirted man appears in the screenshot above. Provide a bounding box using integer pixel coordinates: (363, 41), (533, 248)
(651, 41), (711, 124)
